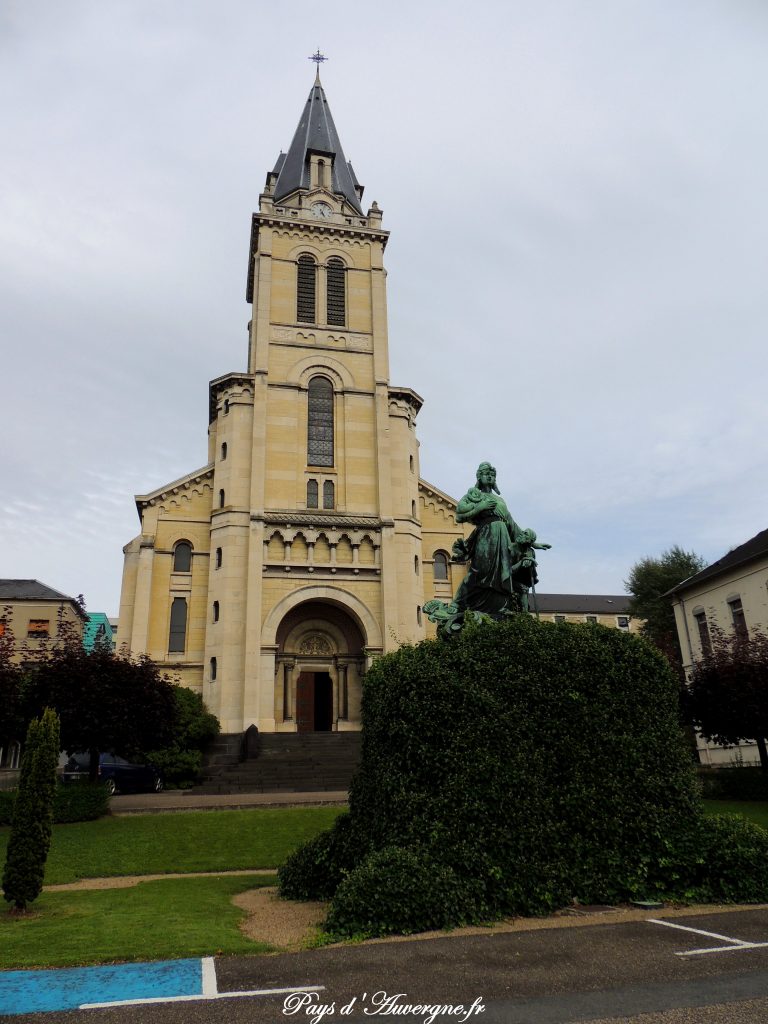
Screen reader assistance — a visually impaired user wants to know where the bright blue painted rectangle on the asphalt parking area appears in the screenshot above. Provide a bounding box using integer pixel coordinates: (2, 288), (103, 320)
(0, 959), (203, 1014)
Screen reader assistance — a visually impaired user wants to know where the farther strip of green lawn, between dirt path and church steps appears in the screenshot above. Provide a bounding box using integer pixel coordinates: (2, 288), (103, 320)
(0, 807), (341, 885)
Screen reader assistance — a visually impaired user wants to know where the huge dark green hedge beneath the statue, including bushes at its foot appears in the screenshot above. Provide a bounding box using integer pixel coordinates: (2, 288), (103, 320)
(281, 615), (768, 935)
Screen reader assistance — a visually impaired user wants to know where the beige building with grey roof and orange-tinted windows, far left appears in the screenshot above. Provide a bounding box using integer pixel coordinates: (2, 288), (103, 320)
(0, 580), (86, 663)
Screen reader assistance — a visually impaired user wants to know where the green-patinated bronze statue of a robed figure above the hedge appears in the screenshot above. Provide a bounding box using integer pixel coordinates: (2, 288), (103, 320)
(424, 462), (552, 637)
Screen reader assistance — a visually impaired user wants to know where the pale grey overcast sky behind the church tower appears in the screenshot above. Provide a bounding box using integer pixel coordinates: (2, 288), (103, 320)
(0, 0), (768, 614)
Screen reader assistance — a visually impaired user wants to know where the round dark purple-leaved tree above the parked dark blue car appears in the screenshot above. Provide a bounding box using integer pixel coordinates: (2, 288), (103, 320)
(25, 641), (176, 781)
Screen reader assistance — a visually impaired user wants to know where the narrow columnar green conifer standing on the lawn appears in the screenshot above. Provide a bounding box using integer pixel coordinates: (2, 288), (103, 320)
(3, 708), (59, 913)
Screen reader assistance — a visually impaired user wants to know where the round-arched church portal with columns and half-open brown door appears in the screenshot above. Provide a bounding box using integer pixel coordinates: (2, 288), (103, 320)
(274, 601), (366, 732)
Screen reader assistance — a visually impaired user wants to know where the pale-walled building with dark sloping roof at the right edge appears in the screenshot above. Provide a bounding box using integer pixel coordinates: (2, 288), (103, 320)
(670, 529), (768, 764)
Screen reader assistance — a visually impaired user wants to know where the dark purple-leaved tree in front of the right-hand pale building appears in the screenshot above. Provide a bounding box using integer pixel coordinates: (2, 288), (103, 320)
(685, 626), (768, 770)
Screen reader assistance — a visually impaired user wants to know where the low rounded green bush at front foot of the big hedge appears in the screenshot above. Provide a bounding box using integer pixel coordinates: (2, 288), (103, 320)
(326, 846), (477, 938)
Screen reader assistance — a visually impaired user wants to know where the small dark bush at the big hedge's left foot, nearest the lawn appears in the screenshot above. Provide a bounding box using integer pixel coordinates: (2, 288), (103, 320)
(278, 814), (366, 899)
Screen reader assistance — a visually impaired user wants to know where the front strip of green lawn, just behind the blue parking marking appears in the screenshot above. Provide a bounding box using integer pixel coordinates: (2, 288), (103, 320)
(0, 872), (275, 970)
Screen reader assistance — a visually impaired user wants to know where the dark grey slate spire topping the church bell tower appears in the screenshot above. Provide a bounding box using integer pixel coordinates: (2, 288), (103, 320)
(274, 75), (362, 215)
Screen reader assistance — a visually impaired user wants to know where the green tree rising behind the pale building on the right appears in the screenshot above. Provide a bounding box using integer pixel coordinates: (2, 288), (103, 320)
(624, 544), (707, 673)
